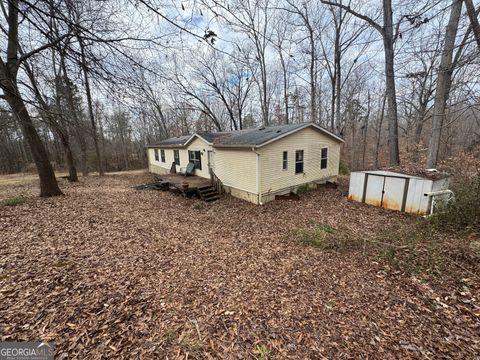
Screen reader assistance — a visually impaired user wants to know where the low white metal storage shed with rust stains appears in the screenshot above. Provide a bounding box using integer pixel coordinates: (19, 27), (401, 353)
(348, 170), (451, 215)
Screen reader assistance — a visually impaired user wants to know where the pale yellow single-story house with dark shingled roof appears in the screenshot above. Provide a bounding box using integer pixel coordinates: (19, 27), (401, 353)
(147, 123), (343, 204)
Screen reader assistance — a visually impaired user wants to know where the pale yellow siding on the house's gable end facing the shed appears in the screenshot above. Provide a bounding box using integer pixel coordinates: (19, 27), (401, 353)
(259, 128), (340, 196)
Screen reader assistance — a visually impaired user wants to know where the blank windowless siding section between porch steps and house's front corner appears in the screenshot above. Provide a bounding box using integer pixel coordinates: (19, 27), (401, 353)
(214, 148), (257, 195)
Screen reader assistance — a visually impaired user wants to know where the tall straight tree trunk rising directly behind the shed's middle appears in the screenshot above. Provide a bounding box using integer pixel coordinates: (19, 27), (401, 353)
(383, 0), (400, 165)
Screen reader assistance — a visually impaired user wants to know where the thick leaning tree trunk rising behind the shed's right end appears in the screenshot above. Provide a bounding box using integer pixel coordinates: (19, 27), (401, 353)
(426, 0), (463, 168)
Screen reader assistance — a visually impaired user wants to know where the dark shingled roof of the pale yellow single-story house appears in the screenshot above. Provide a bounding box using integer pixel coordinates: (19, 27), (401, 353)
(151, 123), (342, 147)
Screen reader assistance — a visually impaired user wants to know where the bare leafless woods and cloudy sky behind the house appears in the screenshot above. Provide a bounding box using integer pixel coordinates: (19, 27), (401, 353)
(0, 0), (480, 196)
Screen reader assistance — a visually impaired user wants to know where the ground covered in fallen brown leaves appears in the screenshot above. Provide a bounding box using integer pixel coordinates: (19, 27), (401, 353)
(0, 175), (480, 359)
